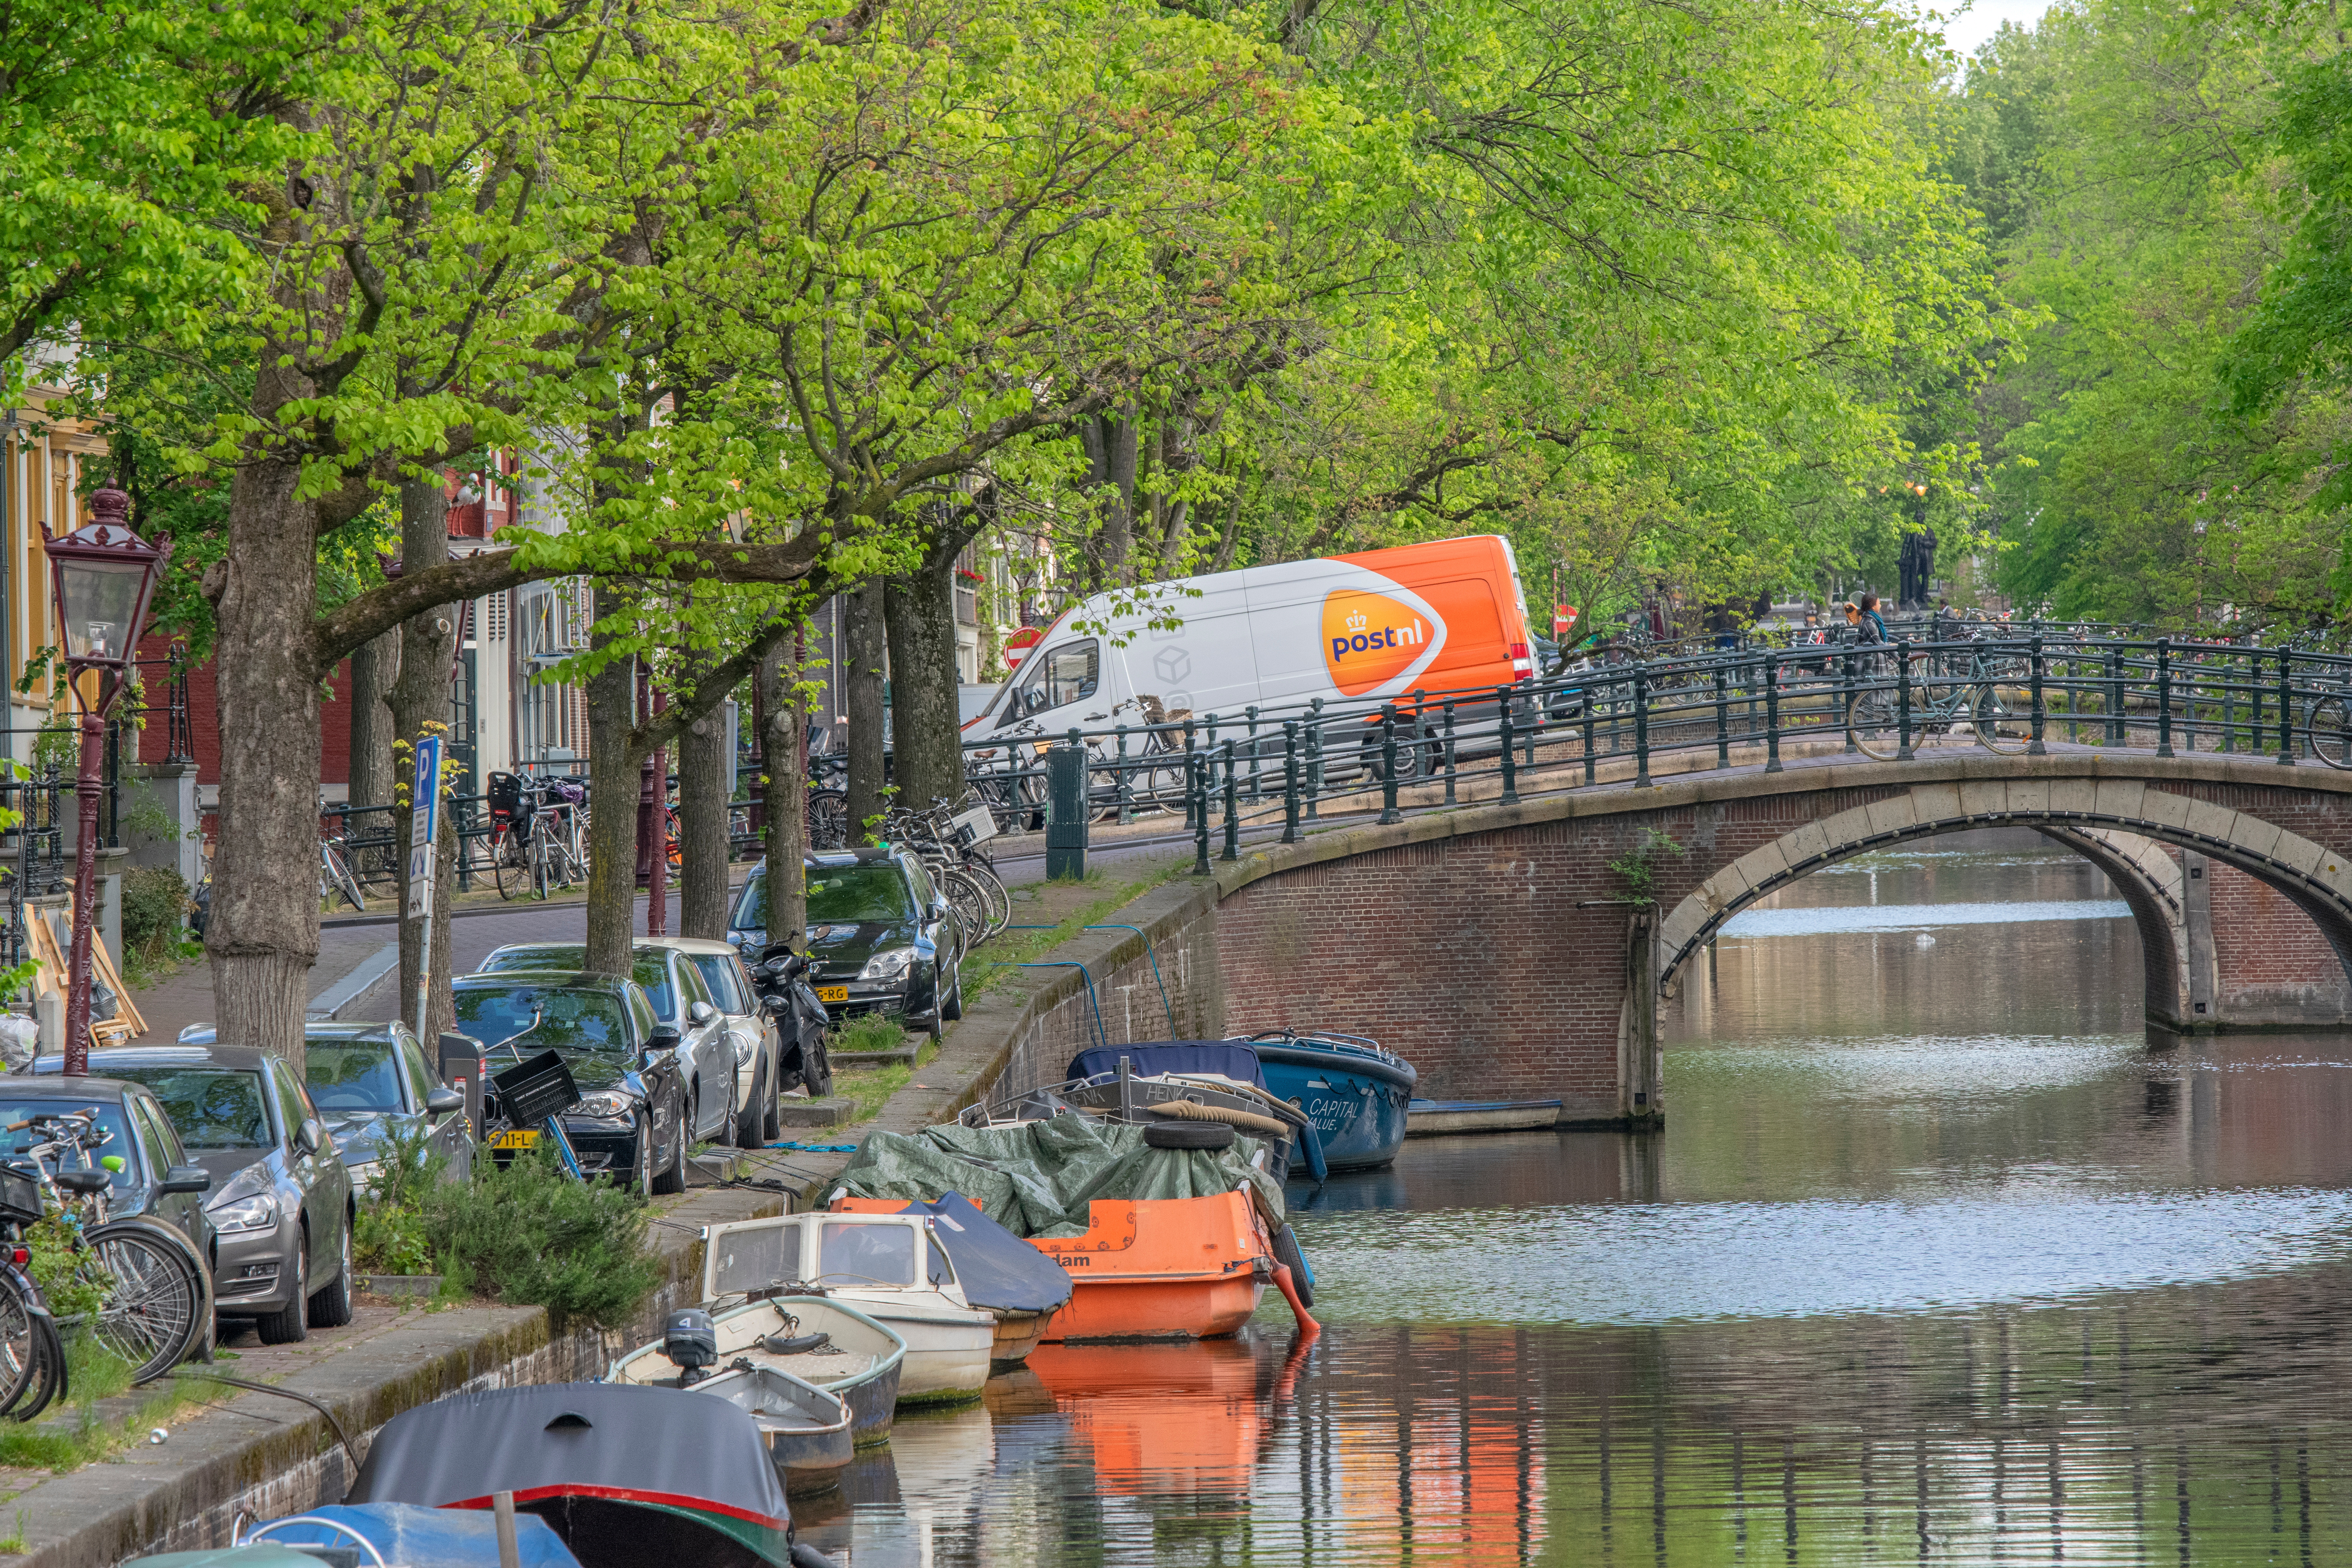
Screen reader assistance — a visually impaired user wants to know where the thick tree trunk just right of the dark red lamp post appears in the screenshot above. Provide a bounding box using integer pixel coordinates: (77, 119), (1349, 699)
(205, 446), (320, 1077)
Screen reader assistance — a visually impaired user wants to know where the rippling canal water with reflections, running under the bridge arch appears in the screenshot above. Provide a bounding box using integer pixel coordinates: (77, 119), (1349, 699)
(797, 832), (2352, 1568)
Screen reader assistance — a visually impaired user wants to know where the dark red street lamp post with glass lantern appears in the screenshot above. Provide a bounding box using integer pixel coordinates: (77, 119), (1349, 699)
(42, 484), (169, 1077)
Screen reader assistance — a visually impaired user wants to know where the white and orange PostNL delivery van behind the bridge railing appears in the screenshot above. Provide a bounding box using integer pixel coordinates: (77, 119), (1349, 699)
(964, 534), (1534, 740)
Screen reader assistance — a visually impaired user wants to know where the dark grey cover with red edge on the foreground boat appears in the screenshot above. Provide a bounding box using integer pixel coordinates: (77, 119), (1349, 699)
(343, 1382), (793, 1566)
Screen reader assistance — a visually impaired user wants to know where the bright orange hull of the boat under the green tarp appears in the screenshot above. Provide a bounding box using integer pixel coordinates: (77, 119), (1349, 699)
(1030, 1192), (1275, 1345)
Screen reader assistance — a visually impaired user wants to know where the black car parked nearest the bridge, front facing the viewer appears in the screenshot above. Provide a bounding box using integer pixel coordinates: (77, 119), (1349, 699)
(727, 849), (964, 1039)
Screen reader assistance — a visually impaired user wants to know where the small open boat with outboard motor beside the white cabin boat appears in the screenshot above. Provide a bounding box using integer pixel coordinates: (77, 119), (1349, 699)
(604, 1288), (906, 1448)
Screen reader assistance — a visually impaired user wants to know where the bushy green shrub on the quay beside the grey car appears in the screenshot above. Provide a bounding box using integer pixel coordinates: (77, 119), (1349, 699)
(423, 1150), (661, 1330)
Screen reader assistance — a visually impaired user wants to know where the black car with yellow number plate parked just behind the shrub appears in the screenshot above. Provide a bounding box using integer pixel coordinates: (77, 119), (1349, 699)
(449, 969), (694, 1192)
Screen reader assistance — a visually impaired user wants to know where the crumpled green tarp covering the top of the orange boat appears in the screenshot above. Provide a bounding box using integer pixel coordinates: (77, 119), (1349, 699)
(828, 1112), (1282, 1241)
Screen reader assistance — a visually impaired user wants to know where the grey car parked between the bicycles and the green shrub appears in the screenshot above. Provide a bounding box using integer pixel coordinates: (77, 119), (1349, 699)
(33, 1044), (355, 1345)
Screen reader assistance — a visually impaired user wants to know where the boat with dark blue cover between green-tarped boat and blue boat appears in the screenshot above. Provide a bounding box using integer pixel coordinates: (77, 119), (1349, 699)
(957, 1039), (1324, 1182)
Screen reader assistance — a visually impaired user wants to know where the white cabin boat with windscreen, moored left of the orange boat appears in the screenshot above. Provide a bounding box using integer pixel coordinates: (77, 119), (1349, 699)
(703, 1213), (997, 1403)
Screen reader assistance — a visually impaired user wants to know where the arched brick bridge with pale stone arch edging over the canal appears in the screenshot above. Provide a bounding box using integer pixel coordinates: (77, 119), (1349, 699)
(1216, 748), (2352, 1122)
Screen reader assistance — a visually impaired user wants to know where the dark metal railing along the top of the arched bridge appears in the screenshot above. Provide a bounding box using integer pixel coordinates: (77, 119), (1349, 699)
(946, 621), (2352, 870)
